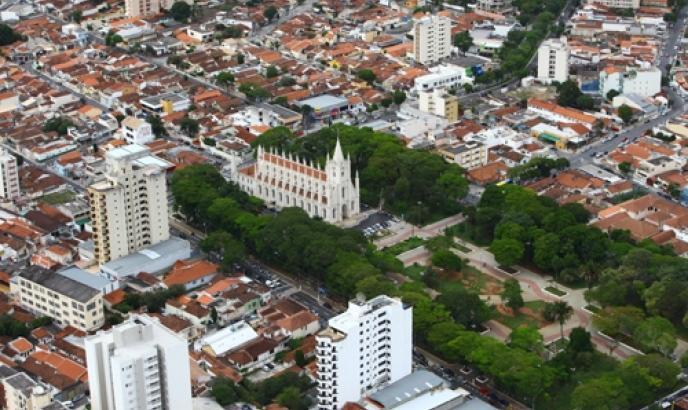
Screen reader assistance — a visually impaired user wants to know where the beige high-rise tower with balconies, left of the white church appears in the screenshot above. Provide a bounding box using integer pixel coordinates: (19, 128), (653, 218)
(88, 144), (170, 264)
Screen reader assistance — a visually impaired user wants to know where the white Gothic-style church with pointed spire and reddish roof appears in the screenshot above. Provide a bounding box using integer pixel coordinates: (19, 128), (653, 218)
(235, 140), (360, 223)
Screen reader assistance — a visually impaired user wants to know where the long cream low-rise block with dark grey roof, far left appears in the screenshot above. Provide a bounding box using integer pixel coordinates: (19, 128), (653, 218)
(10, 266), (105, 332)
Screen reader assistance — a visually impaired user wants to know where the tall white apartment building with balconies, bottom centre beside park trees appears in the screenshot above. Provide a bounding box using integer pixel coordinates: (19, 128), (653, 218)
(316, 295), (413, 410)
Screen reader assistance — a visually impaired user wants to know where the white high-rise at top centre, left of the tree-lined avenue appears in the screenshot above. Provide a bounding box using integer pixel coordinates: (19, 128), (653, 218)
(413, 16), (452, 64)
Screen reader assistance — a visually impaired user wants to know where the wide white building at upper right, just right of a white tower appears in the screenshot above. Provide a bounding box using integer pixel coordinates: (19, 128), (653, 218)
(600, 66), (662, 97)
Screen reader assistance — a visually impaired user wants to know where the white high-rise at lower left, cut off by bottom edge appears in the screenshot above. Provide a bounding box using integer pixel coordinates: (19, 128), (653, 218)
(85, 315), (193, 410)
